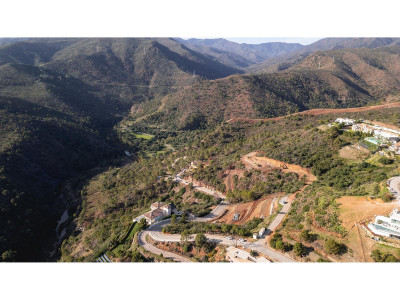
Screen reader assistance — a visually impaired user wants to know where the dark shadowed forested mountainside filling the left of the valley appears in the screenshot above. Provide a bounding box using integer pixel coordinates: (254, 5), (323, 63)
(0, 39), (239, 261)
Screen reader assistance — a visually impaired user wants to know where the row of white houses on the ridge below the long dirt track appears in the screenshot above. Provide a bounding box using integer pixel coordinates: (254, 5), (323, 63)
(335, 118), (400, 154)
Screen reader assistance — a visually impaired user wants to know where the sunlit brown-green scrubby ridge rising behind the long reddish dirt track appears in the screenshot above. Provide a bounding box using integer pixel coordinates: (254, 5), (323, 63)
(134, 47), (400, 129)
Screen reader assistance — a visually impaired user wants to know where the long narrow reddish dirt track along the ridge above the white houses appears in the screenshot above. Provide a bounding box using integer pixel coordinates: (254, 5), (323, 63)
(227, 102), (400, 123)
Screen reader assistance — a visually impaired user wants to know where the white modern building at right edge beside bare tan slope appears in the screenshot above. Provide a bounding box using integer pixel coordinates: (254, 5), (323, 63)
(368, 208), (400, 239)
